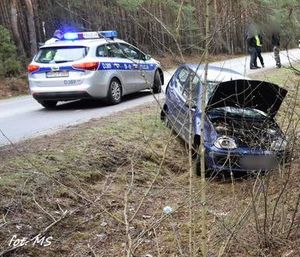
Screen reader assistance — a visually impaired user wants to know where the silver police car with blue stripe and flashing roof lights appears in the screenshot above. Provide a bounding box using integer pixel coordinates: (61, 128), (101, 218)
(28, 31), (164, 108)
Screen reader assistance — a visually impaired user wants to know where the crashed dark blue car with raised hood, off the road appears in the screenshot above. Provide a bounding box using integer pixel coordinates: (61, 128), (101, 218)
(161, 64), (287, 175)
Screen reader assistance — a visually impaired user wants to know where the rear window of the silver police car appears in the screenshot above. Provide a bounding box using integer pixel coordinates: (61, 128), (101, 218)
(34, 46), (88, 63)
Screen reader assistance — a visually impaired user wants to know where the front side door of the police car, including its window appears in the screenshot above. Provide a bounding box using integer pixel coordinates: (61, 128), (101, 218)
(119, 43), (148, 91)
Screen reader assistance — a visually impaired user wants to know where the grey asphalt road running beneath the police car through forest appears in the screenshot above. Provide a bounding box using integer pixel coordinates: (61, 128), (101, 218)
(0, 49), (300, 146)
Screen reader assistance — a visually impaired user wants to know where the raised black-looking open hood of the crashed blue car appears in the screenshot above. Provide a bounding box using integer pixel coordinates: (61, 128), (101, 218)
(206, 79), (287, 118)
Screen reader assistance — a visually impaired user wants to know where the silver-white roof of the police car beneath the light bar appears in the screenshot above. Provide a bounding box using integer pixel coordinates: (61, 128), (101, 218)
(40, 38), (126, 49)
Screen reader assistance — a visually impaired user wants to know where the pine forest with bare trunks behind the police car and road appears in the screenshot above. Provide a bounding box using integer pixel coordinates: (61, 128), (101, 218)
(0, 0), (300, 62)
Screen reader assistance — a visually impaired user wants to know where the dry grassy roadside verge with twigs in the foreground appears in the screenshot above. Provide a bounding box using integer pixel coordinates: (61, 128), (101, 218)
(0, 66), (300, 257)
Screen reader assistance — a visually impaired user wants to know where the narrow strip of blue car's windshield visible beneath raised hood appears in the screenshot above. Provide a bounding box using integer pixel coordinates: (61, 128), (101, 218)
(210, 106), (267, 119)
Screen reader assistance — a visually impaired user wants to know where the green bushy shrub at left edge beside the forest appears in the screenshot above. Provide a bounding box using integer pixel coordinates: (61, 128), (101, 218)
(0, 25), (22, 77)
